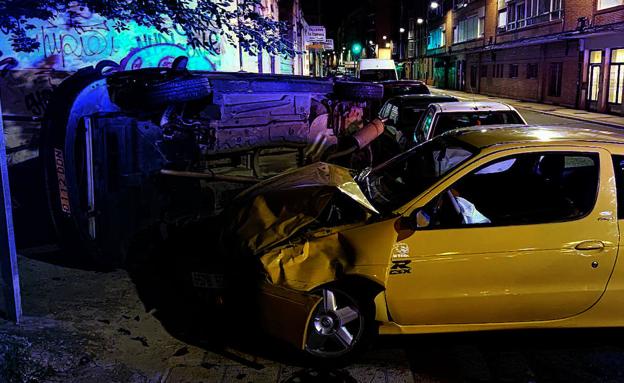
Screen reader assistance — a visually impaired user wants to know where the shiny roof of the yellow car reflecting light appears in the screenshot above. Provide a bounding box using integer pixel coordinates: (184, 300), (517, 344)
(442, 124), (624, 149)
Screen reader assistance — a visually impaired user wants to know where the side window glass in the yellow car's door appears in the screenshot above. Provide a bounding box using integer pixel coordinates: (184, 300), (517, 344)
(423, 152), (600, 227)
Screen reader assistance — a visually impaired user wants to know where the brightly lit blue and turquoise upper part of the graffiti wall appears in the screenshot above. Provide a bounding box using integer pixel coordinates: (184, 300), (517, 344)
(0, 8), (228, 71)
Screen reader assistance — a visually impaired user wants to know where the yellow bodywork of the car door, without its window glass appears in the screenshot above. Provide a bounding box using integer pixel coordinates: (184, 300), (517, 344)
(387, 149), (619, 325)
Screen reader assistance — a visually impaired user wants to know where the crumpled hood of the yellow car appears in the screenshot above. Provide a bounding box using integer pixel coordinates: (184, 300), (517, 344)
(227, 162), (378, 254)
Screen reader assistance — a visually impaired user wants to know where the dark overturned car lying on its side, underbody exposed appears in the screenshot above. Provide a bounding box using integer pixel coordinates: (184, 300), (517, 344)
(40, 57), (383, 264)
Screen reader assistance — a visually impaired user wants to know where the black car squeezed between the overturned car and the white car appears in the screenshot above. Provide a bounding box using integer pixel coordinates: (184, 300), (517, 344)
(375, 94), (459, 163)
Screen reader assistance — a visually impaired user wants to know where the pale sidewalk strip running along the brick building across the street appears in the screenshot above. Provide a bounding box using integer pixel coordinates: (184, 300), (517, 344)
(429, 86), (624, 129)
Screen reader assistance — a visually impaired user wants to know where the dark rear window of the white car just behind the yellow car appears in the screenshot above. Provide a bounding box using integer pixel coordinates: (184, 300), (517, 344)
(434, 110), (524, 136)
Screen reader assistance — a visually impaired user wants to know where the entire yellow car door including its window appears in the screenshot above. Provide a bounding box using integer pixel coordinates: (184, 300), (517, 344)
(386, 147), (619, 325)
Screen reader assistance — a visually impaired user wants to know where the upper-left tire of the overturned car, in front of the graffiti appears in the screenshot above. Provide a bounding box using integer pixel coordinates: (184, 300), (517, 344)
(107, 68), (212, 109)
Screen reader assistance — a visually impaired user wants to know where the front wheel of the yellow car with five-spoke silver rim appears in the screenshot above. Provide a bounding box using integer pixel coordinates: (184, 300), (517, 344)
(304, 286), (377, 364)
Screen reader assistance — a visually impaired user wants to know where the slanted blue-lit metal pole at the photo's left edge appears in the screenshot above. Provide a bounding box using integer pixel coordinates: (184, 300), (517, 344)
(0, 93), (22, 323)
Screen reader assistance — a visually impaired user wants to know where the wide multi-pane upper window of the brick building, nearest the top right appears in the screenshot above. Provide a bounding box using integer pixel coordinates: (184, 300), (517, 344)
(498, 0), (564, 30)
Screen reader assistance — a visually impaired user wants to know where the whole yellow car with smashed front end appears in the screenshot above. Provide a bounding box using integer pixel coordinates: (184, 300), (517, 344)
(227, 126), (624, 358)
